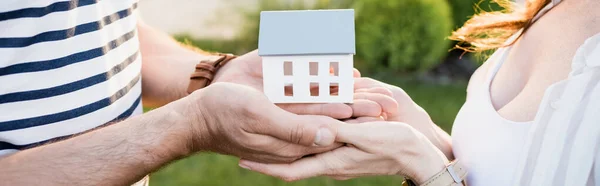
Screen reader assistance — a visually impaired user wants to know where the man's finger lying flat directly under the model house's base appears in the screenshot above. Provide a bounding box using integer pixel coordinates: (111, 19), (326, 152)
(277, 103), (352, 119)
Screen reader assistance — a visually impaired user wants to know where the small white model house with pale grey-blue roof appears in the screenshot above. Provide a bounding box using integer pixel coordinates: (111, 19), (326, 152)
(258, 10), (356, 103)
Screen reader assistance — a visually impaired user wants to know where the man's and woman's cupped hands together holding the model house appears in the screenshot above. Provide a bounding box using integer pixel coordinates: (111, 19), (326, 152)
(175, 52), (448, 182)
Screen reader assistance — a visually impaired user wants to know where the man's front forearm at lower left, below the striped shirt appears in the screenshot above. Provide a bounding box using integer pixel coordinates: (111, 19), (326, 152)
(0, 99), (189, 185)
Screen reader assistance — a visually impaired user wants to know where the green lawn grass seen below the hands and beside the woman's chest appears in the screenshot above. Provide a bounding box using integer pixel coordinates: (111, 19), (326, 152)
(150, 74), (466, 186)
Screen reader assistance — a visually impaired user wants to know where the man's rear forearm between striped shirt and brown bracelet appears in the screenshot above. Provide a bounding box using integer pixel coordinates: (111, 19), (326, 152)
(138, 22), (218, 107)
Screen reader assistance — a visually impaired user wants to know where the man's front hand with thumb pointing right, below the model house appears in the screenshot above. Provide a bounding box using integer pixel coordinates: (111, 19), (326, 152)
(184, 83), (341, 162)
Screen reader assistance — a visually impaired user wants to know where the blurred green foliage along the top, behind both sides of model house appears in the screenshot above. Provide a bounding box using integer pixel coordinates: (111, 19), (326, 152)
(176, 0), (452, 73)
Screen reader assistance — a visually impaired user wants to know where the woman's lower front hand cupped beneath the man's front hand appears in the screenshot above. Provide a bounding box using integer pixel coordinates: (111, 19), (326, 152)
(240, 122), (448, 183)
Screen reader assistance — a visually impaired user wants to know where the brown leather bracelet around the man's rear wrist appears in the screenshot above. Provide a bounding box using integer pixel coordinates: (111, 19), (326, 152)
(187, 54), (236, 94)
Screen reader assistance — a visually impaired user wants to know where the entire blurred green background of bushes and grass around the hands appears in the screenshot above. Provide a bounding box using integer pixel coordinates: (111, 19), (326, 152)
(150, 0), (498, 186)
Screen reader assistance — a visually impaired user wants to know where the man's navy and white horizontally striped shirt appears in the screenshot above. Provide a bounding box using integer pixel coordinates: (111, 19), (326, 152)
(0, 0), (142, 156)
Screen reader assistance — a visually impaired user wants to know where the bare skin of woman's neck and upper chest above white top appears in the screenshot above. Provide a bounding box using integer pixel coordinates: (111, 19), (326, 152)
(490, 3), (600, 121)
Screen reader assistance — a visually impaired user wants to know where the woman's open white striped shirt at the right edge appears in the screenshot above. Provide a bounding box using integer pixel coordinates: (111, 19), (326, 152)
(512, 34), (600, 186)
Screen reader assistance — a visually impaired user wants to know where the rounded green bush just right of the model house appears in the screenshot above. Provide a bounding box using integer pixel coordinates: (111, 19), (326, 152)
(355, 0), (452, 72)
